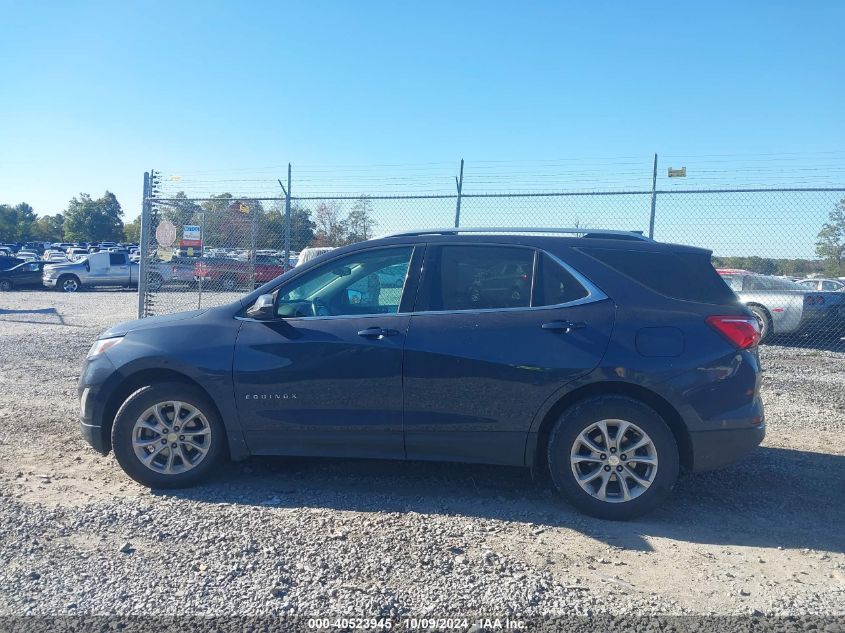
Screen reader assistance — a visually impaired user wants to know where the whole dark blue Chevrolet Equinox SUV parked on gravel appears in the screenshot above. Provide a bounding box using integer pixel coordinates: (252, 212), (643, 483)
(79, 229), (765, 519)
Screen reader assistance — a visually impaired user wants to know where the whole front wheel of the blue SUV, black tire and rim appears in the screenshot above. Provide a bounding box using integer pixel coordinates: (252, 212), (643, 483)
(111, 382), (226, 488)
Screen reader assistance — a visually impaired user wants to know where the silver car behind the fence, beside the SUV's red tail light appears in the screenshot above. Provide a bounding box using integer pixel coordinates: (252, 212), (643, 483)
(718, 268), (845, 341)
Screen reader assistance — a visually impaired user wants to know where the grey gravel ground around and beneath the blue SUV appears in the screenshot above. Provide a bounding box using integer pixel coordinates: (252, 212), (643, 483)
(0, 291), (845, 617)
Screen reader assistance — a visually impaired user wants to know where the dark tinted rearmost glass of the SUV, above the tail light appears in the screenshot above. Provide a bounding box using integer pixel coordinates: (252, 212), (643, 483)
(580, 248), (736, 304)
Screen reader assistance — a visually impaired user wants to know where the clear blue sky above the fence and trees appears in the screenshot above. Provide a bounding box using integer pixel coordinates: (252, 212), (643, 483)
(0, 0), (845, 233)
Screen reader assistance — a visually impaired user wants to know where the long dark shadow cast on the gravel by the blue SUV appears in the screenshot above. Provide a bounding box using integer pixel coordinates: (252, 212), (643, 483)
(155, 447), (845, 552)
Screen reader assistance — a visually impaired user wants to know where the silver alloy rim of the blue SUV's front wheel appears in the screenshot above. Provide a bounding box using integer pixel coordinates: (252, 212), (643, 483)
(132, 401), (211, 475)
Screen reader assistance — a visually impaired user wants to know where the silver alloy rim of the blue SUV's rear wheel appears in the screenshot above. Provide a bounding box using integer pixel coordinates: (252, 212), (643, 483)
(569, 419), (658, 503)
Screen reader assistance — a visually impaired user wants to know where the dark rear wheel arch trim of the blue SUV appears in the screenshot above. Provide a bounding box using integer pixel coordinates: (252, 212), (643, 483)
(525, 381), (693, 473)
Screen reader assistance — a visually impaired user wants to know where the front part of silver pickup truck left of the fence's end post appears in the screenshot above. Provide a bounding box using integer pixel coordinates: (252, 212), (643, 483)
(43, 252), (138, 292)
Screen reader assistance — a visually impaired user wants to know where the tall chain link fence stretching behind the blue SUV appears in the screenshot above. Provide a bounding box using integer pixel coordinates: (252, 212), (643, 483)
(138, 163), (845, 348)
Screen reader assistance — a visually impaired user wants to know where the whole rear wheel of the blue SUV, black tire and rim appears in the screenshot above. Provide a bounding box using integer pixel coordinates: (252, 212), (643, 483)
(547, 395), (679, 521)
